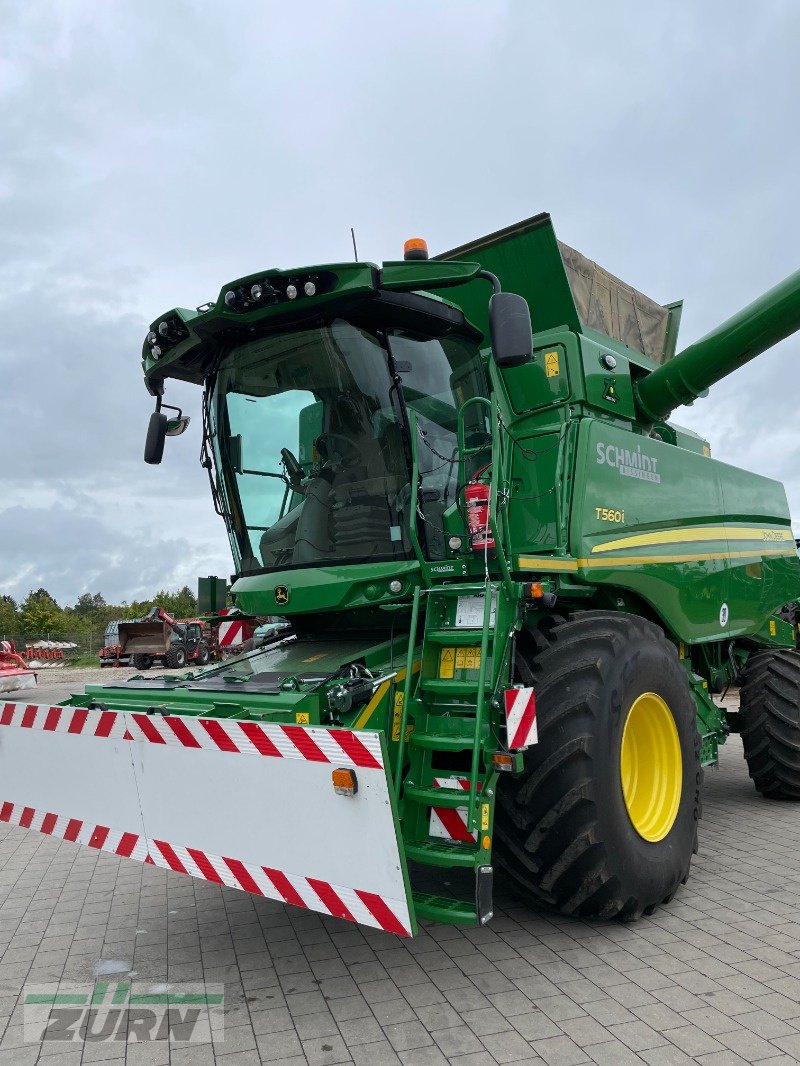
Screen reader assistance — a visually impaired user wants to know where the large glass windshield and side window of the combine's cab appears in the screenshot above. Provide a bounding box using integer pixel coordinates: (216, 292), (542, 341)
(208, 319), (485, 572)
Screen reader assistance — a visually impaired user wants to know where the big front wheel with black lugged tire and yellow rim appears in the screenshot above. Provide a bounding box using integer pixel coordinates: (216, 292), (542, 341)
(495, 611), (702, 921)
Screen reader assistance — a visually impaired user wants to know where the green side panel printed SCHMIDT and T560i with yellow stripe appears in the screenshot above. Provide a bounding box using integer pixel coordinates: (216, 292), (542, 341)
(550, 418), (800, 643)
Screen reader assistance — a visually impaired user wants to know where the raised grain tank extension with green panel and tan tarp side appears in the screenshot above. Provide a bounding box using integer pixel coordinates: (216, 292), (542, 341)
(436, 213), (681, 365)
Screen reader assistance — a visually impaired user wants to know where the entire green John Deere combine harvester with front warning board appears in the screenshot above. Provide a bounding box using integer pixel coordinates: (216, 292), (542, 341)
(0, 214), (800, 935)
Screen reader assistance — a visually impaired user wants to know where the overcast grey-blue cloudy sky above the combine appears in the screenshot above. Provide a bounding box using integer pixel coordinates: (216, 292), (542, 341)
(0, 0), (800, 604)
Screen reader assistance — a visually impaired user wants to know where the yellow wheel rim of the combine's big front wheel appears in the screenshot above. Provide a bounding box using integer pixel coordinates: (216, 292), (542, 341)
(620, 692), (683, 842)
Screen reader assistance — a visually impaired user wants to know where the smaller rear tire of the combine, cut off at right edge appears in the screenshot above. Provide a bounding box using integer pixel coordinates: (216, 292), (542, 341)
(739, 648), (800, 800)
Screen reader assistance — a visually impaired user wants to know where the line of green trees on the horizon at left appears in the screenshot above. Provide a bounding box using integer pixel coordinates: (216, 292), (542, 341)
(0, 585), (197, 640)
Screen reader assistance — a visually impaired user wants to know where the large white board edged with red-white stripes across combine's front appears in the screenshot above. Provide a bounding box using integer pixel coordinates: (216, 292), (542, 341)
(0, 702), (414, 936)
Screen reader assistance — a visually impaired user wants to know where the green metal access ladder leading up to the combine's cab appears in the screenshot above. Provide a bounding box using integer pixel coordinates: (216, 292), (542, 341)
(399, 580), (517, 924)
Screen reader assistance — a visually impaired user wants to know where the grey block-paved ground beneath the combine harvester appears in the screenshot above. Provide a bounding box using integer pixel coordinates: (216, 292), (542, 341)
(0, 687), (800, 1066)
